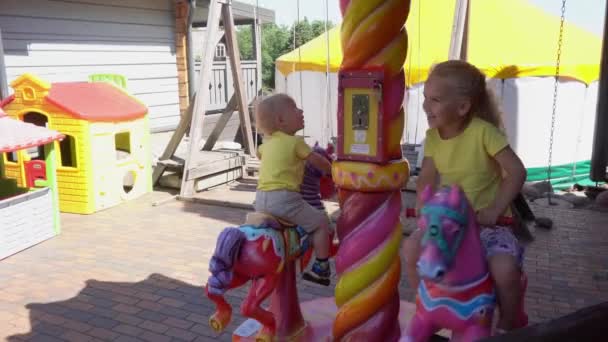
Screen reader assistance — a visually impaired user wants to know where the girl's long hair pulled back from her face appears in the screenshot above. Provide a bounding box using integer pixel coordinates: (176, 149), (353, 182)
(429, 60), (504, 131)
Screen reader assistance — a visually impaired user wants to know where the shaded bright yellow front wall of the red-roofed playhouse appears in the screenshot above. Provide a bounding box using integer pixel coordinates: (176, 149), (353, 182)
(4, 99), (95, 214)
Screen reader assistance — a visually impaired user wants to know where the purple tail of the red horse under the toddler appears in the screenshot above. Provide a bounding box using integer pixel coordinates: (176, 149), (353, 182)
(207, 227), (246, 296)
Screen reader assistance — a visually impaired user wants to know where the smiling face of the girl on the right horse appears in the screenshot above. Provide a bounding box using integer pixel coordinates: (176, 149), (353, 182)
(422, 77), (470, 128)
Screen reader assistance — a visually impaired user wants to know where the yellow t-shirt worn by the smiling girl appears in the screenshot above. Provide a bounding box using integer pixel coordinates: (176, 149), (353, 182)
(424, 117), (510, 214)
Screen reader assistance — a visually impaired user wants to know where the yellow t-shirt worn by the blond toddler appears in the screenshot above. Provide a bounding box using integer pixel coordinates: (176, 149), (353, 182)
(258, 131), (312, 191)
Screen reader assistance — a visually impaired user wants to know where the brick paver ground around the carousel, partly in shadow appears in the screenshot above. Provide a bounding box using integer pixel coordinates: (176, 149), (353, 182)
(0, 192), (608, 342)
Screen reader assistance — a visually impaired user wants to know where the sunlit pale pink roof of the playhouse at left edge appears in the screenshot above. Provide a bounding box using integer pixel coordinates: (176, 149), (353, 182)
(0, 109), (64, 152)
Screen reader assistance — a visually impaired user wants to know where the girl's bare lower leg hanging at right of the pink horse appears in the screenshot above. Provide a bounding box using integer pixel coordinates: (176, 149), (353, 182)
(488, 253), (522, 330)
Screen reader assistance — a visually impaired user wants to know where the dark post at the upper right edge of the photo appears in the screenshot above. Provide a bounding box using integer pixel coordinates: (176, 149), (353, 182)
(589, 2), (608, 182)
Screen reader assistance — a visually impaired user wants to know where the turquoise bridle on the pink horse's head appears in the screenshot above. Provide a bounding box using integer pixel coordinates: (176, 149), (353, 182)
(421, 205), (467, 267)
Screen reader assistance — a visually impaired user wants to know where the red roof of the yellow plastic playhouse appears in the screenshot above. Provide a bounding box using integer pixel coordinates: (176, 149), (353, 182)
(46, 82), (148, 121)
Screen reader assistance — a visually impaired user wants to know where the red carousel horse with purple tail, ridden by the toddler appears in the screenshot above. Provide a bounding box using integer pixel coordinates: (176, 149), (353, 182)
(205, 144), (337, 341)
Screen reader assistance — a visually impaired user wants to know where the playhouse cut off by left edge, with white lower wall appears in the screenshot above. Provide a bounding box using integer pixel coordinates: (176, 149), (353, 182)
(0, 109), (63, 259)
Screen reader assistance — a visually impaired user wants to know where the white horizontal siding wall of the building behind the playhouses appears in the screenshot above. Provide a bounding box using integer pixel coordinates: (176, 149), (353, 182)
(0, 0), (179, 130)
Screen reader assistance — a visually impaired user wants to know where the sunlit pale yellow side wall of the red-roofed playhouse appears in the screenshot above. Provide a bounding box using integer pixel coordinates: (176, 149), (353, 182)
(90, 116), (152, 211)
